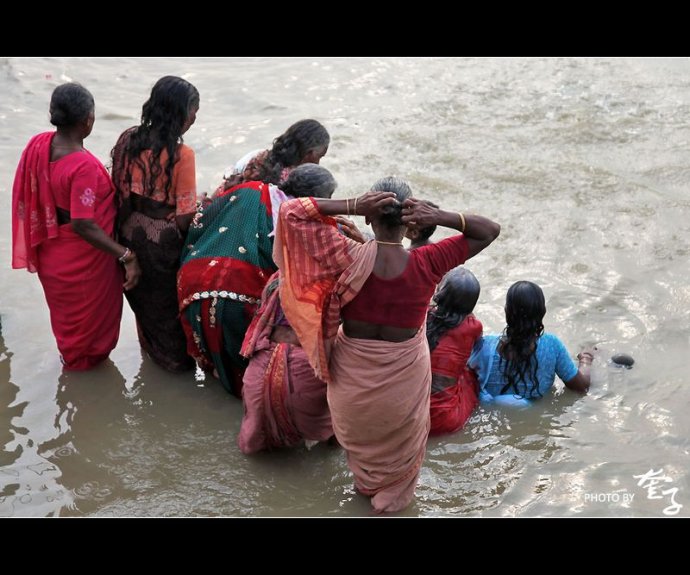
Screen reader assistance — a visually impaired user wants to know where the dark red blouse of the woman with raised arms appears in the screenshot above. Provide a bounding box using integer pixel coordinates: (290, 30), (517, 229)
(342, 234), (469, 328)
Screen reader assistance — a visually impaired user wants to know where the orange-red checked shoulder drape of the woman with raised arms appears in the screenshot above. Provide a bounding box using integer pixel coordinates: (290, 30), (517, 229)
(273, 198), (377, 382)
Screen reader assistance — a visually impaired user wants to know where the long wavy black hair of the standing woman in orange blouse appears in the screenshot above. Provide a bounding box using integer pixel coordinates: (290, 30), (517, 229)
(111, 76), (199, 202)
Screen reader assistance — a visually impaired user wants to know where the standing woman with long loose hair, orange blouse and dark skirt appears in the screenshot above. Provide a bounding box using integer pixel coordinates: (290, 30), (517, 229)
(112, 76), (199, 372)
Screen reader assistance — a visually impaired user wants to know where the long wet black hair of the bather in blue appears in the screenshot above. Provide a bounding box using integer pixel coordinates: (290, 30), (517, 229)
(499, 281), (546, 397)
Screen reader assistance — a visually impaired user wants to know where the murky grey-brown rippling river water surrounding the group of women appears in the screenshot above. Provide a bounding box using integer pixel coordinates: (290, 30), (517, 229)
(0, 58), (690, 517)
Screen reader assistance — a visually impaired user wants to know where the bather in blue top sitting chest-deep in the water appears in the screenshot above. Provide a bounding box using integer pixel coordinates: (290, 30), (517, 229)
(467, 281), (594, 405)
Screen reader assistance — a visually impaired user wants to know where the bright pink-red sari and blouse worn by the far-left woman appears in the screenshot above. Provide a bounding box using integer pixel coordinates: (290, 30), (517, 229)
(12, 132), (123, 370)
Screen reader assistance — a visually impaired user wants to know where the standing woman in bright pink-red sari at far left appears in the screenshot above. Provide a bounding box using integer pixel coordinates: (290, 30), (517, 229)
(12, 83), (140, 370)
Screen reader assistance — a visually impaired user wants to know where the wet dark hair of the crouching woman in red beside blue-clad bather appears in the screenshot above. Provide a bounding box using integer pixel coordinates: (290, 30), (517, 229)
(426, 266), (480, 351)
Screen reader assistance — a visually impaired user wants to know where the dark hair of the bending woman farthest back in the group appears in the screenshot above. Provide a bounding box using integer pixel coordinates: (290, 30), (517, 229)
(259, 120), (331, 185)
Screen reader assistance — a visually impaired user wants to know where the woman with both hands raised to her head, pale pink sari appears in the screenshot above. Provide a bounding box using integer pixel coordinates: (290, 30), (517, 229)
(274, 178), (500, 513)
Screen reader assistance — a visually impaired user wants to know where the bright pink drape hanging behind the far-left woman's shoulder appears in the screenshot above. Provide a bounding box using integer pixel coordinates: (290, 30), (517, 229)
(12, 132), (58, 272)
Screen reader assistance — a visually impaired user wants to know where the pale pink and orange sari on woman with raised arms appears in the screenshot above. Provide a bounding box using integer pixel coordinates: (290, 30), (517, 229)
(273, 198), (431, 513)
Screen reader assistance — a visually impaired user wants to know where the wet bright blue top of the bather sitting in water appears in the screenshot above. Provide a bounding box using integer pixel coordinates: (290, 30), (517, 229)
(467, 333), (577, 405)
